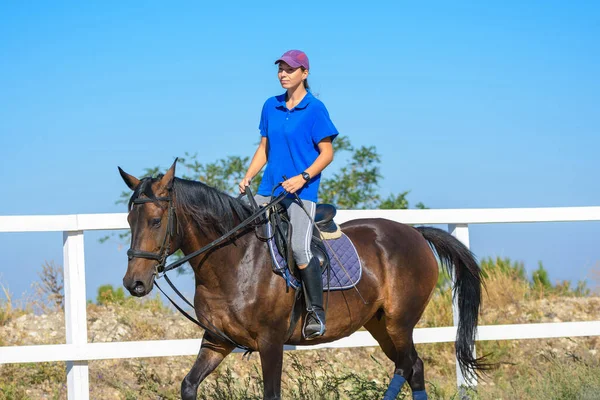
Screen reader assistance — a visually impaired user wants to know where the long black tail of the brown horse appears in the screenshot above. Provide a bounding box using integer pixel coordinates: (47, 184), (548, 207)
(416, 226), (493, 379)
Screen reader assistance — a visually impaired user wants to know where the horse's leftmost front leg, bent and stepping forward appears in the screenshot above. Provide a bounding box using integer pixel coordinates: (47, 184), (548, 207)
(181, 332), (234, 400)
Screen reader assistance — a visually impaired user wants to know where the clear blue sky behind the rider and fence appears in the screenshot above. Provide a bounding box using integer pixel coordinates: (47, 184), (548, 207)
(0, 1), (600, 304)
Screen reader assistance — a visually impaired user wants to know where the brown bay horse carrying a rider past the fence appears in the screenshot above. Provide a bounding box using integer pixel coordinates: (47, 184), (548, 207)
(119, 163), (486, 400)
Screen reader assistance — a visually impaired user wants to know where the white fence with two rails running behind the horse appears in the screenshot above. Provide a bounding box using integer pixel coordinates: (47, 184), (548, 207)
(0, 207), (600, 400)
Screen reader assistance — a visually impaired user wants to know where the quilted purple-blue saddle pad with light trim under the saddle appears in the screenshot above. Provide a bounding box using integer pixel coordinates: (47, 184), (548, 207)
(267, 224), (362, 291)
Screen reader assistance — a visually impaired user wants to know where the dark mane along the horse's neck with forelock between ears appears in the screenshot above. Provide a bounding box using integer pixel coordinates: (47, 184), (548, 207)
(129, 175), (252, 235)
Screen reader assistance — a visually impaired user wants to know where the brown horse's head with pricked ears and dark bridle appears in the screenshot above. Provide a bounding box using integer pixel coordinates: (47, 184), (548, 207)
(119, 160), (177, 297)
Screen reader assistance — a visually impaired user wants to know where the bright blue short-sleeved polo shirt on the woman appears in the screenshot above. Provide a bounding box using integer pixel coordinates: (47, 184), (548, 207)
(258, 92), (338, 202)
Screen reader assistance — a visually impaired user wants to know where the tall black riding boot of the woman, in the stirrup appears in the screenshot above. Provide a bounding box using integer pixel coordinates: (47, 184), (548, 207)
(299, 257), (325, 339)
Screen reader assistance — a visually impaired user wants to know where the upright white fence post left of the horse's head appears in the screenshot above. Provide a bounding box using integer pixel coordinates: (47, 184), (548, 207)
(63, 231), (90, 400)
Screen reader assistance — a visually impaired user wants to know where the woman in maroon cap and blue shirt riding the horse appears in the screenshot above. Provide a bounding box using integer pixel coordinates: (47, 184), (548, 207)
(239, 50), (338, 339)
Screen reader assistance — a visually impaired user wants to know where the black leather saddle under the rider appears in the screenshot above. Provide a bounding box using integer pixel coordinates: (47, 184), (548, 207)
(268, 204), (341, 276)
